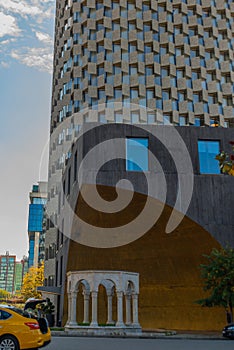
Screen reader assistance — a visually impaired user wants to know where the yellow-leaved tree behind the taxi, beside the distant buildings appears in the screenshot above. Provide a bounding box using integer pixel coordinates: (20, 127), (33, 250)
(21, 263), (44, 300)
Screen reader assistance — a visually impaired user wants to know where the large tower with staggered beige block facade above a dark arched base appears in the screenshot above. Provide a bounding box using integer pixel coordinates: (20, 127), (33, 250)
(43, 0), (234, 329)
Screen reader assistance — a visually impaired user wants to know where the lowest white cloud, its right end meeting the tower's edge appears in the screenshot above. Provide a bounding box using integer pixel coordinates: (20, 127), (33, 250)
(10, 48), (53, 73)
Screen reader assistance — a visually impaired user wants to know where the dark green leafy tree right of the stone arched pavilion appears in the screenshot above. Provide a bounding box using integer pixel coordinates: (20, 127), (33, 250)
(197, 247), (234, 318)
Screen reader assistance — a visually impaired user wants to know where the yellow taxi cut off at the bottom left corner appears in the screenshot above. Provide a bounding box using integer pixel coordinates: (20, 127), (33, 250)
(0, 305), (51, 350)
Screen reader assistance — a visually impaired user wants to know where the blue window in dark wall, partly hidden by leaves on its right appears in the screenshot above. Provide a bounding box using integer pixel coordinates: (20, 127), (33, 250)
(198, 140), (220, 174)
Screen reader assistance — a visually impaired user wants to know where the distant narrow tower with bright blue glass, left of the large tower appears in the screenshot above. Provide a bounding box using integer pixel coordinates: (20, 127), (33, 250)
(28, 181), (47, 267)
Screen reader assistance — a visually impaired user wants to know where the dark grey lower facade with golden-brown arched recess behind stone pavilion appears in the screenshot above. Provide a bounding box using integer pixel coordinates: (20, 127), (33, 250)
(57, 124), (234, 330)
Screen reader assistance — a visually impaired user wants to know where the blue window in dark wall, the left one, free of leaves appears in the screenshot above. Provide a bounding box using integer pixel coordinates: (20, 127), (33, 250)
(126, 138), (149, 171)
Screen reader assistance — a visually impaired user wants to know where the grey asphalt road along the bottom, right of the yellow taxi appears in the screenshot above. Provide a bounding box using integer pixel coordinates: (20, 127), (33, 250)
(46, 337), (234, 350)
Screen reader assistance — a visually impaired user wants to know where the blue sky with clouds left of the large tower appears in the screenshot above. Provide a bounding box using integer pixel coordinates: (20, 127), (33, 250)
(0, 0), (55, 259)
